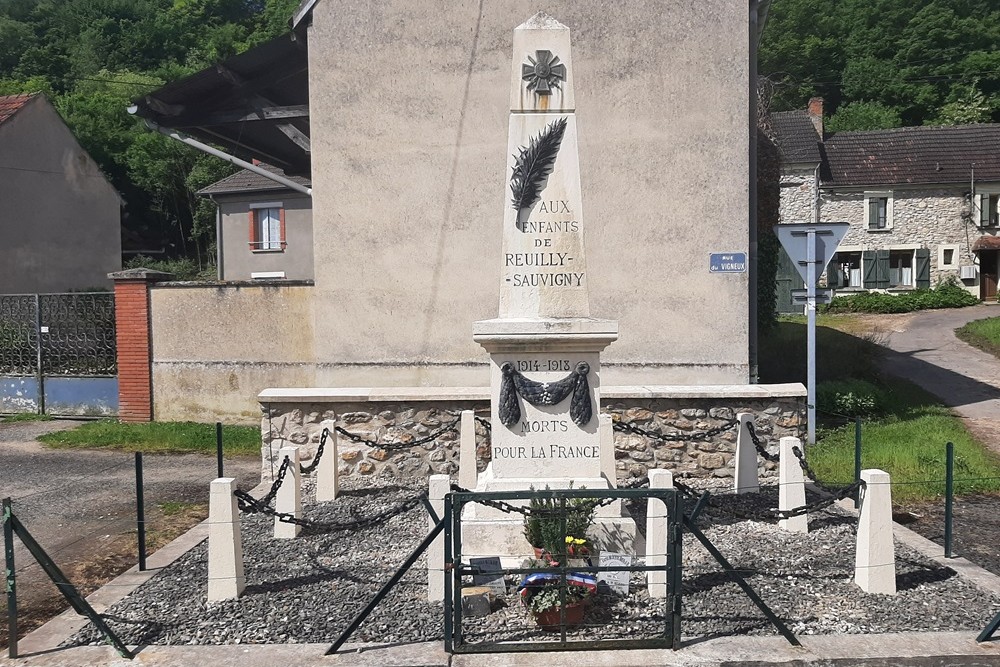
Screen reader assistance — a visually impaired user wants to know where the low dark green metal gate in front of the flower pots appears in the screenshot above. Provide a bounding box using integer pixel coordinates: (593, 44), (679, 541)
(444, 488), (683, 653)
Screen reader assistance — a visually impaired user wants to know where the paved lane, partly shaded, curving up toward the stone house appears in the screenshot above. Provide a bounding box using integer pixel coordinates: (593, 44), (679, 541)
(883, 305), (1000, 452)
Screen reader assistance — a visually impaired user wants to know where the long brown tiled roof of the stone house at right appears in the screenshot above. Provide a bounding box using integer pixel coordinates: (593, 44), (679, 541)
(821, 124), (1000, 186)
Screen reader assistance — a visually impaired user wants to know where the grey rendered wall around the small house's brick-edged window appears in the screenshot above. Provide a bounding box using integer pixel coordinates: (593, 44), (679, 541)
(213, 191), (313, 280)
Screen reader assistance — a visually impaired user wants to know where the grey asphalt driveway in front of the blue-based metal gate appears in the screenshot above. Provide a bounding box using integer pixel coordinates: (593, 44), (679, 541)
(0, 420), (260, 644)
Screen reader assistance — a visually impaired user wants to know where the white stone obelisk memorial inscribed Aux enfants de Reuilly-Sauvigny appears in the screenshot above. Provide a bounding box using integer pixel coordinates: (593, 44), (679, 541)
(463, 13), (634, 555)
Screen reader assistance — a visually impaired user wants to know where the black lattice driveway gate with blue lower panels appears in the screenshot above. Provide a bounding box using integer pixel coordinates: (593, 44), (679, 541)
(0, 292), (118, 416)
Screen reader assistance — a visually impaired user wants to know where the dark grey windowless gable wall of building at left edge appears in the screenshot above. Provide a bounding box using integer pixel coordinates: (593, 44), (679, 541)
(0, 96), (121, 294)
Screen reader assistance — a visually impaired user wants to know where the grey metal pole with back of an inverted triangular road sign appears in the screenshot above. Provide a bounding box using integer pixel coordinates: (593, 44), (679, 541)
(774, 222), (850, 445)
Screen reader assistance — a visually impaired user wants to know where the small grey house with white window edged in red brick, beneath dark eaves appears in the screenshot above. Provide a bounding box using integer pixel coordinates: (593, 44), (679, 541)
(198, 165), (313, 281)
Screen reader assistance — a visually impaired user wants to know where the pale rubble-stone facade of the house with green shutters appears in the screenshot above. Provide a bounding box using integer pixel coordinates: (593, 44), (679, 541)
(820, 186), (982, 296)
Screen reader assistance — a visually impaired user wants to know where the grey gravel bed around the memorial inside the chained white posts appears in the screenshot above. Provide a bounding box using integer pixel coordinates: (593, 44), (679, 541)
(70, 479), (1000, 644)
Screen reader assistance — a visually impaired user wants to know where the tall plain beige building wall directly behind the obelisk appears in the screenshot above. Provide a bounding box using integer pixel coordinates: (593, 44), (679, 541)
(309, 0), (749, 387)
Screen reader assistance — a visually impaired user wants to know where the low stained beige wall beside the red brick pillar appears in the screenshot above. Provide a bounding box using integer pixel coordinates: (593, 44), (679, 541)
(150, 283), (314, 424)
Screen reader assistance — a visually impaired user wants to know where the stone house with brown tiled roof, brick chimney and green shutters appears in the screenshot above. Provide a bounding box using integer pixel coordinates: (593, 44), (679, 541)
(772, 98), (1000, 299)
